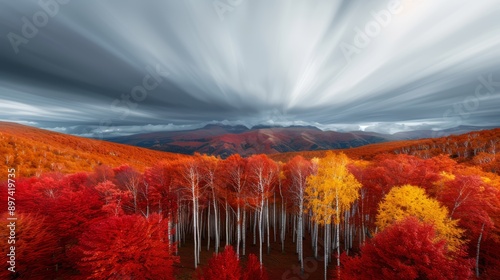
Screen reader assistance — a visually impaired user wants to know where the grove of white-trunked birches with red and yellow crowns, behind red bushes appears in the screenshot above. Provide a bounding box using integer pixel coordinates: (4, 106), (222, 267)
(100, 152), (492, 277)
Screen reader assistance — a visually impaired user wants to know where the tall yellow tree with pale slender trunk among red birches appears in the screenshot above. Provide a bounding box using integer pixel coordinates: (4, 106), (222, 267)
(306, 152), (361, 279)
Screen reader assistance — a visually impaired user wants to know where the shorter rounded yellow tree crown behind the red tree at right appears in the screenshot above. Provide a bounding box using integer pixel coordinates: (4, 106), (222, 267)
(376, 185), (464, 251)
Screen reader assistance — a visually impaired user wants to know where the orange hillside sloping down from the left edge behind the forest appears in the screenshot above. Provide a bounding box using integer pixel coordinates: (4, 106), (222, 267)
(0, 122), (186, 176)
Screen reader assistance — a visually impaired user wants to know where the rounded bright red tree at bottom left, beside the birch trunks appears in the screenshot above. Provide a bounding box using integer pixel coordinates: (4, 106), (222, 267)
(75, 215), (178, 279)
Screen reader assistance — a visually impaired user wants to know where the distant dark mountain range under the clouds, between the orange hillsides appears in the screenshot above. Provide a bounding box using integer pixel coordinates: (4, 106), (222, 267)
(105, 124), (496, 158)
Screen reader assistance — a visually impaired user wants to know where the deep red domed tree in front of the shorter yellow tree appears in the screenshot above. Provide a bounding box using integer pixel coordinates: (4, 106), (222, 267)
(341, 217), (472, 279)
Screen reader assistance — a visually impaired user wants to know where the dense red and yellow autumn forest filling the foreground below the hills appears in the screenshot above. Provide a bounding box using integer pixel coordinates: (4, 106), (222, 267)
(0, 146), (500, 279)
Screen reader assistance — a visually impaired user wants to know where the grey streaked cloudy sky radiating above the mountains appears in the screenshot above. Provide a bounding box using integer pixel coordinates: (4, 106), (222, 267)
(0, 0), (500, 137)
